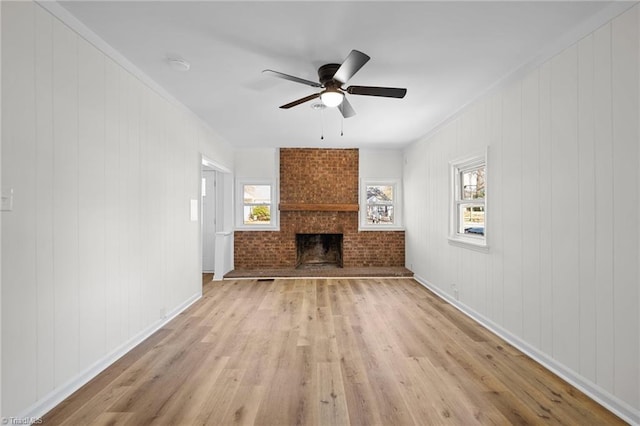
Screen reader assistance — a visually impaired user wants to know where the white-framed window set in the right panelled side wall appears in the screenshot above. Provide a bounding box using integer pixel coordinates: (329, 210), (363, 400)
(449, 154), (487, 248)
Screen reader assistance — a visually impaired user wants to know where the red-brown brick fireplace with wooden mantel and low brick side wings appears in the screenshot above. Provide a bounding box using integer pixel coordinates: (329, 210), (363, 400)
(234, 148), (404, 270)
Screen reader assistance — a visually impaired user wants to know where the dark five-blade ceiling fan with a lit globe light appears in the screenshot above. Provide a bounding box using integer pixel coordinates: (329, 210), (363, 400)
(262, 50), (407, 118)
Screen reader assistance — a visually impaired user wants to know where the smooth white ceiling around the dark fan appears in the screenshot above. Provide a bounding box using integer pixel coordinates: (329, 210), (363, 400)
(56, 1), (632, 148)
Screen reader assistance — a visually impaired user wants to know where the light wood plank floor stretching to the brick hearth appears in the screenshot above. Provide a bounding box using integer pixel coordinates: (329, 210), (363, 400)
(43, 278), (624, 425)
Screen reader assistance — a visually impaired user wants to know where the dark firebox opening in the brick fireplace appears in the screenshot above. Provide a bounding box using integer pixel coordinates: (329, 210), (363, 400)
(296, 234), (342, 269)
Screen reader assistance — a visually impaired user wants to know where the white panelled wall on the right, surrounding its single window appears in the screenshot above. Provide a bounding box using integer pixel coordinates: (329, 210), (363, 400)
(404, 6), (640, 422)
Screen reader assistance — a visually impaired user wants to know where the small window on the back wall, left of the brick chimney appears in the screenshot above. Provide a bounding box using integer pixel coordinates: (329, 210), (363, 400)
(236, 182), (277, 230)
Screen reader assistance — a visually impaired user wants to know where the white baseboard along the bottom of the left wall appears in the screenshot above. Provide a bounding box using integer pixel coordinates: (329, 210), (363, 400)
(14, 292), (202, 419)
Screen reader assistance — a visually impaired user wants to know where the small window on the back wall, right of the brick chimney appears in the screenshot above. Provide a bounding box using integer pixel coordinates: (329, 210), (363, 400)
(360, 180), (401, 230)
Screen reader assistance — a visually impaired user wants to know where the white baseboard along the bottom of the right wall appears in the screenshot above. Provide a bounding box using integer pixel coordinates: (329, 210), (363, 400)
(413, 275), (640, 425)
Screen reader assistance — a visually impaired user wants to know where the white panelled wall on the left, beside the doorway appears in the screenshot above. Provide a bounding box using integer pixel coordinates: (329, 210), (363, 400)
(1, 2), (233, 417)
